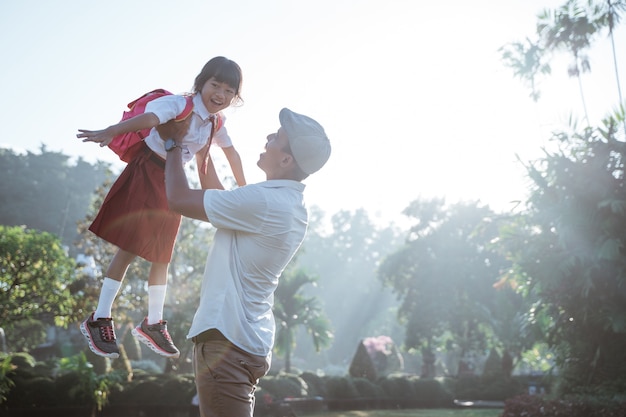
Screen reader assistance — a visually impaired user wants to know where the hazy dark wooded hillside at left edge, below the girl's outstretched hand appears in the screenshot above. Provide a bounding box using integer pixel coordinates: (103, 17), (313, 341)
(0, 145), (110, 246)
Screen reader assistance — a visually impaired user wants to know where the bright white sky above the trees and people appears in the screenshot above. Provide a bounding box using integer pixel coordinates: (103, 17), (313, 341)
(0, 0), (626, 228)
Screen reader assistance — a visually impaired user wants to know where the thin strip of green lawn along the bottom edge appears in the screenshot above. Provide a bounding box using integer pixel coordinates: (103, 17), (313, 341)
(306, 408), (502, 417)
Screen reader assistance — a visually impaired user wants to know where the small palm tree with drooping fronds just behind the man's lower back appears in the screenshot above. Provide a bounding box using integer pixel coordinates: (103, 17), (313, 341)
(274, 261), (333, 373)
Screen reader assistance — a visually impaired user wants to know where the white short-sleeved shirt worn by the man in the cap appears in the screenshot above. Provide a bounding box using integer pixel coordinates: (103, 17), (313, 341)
(187, 180), (308, 356)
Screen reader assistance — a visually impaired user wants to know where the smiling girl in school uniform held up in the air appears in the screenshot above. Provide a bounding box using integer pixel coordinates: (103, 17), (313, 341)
(76, 57), (245, 358)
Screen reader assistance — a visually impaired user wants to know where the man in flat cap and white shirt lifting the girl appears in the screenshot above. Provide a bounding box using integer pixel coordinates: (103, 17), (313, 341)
(162, 109), (331, 417)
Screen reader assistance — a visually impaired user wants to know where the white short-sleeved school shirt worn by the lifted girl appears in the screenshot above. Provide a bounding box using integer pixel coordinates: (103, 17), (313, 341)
(145, 94), (233, 162)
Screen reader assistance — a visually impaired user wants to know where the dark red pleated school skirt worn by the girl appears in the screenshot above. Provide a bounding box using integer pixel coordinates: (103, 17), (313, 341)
(89, 144), (181, 263)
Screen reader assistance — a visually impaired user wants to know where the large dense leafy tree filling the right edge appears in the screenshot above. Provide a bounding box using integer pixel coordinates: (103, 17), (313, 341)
(501, 107), (626, 393)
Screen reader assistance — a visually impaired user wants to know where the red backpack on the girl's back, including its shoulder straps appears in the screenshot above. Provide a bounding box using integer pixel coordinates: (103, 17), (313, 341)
(109, 88), (193, 162)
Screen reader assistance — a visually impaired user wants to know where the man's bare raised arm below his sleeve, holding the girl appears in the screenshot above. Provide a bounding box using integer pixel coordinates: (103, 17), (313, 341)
(165, 147), (215, 222)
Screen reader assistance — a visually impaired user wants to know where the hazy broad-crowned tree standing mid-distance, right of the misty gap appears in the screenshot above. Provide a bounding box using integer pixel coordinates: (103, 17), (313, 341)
(379, 199), (508, 377)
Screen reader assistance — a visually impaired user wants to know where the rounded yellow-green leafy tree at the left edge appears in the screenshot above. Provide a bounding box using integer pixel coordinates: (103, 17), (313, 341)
(0, 225), (77, 351)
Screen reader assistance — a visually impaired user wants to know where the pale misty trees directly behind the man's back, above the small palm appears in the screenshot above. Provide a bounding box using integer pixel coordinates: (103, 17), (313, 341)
(294, 207), (402, 369)
